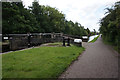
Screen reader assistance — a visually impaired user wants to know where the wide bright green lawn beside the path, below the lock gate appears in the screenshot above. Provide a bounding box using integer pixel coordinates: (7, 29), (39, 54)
(2, 43), (84, 78)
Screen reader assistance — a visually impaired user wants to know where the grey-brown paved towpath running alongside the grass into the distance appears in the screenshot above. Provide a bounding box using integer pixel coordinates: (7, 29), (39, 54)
(60, 37), (118, 78)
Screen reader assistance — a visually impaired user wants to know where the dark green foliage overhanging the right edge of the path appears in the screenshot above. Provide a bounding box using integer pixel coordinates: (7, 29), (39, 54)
(99, 1), (120, 49)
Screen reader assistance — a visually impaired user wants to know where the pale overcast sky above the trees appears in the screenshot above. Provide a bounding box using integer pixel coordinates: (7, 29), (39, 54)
(22, 0), (119, 31)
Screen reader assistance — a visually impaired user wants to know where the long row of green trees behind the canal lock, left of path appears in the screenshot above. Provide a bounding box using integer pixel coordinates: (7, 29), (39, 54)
(2, 2), (89, 36)
